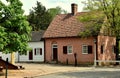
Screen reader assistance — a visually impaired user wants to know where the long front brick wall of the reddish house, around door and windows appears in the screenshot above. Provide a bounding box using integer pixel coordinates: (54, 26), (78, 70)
(45, 37), (94, 64)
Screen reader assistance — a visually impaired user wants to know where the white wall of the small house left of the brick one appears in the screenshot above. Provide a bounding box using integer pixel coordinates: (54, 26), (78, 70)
(0, 41), (44, 62)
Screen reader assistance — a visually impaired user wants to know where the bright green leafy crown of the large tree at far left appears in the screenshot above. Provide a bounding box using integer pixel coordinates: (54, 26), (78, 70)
(0, 0), (31, 63)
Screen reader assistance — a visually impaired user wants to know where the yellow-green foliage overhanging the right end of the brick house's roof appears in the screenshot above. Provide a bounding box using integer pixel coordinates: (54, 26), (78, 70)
(78, 11), (104, 37)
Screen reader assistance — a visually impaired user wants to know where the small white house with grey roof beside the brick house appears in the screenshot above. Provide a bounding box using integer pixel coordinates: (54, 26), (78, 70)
(0, 30), (44, 62)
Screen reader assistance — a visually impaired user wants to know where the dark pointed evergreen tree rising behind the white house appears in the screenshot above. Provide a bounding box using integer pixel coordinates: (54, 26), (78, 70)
(28, 1), (51, 31)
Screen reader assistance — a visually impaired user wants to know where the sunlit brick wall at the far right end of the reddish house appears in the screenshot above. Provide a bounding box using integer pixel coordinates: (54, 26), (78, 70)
(97, 36), (116, 60)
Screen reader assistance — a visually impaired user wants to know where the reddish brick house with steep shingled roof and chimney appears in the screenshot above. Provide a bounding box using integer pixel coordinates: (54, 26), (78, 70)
(43, 4), (116, 64)
